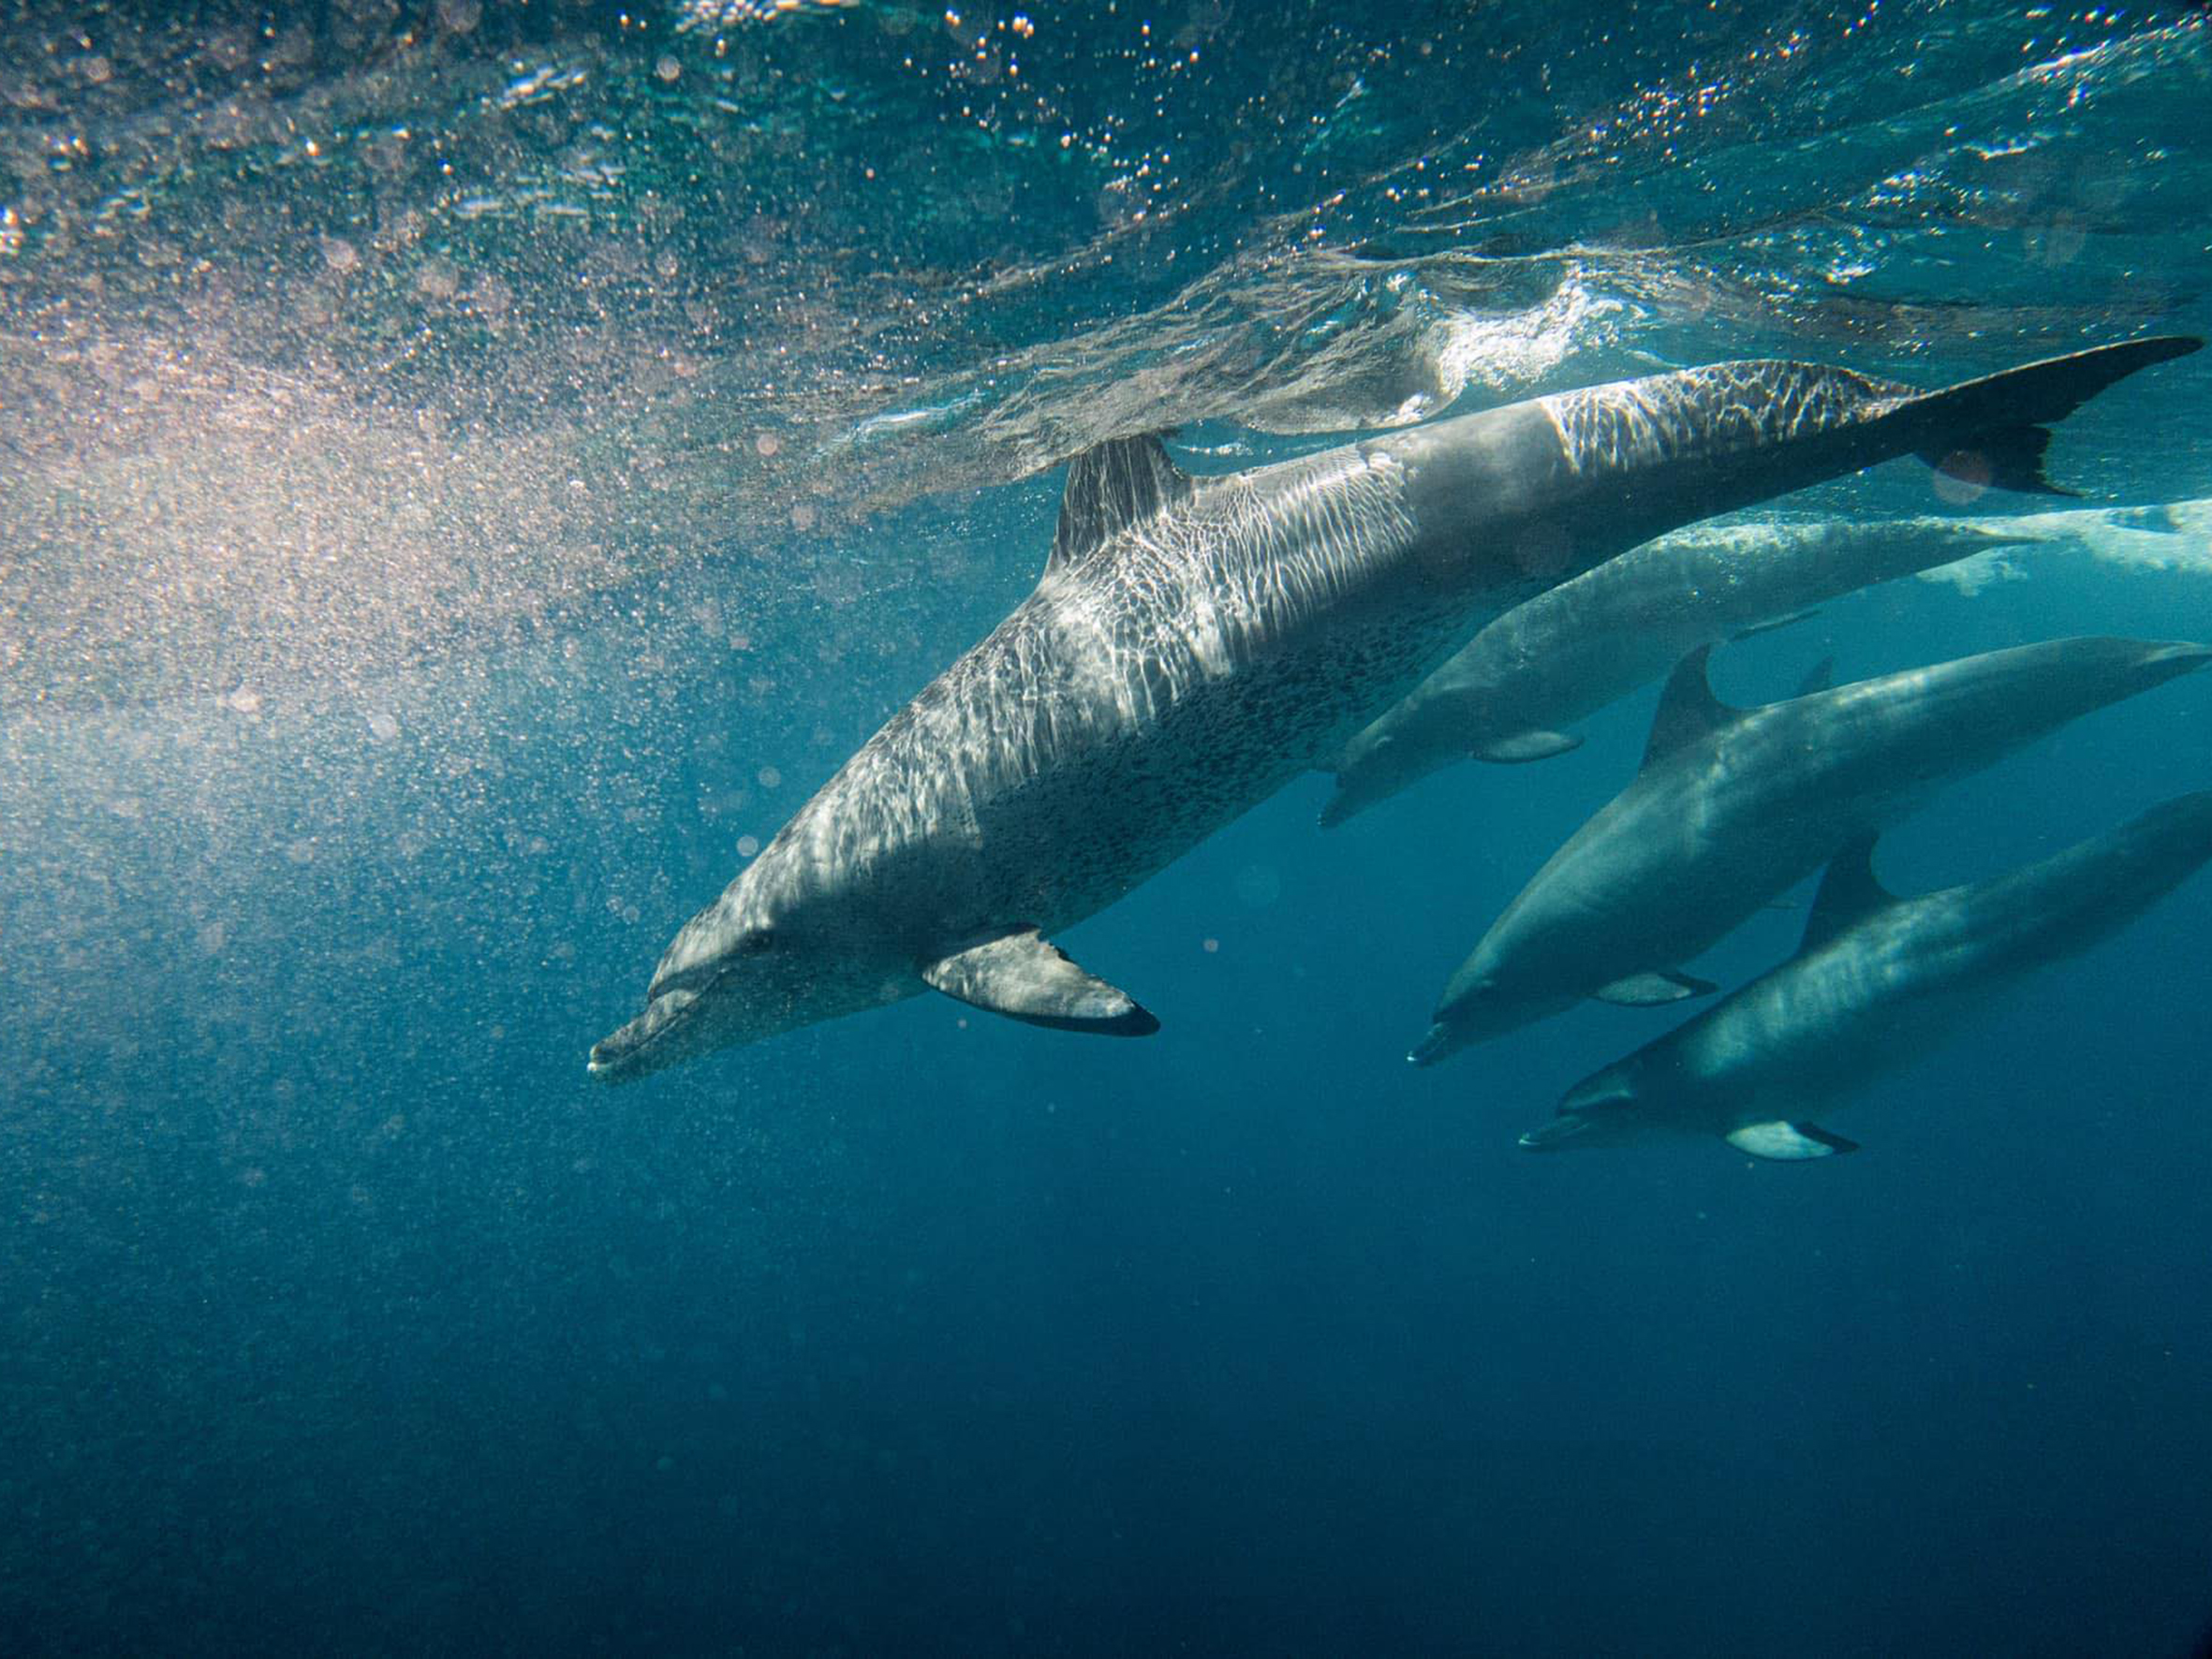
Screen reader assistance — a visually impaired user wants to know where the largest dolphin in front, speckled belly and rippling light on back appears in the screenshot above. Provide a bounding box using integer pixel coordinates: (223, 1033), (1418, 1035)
(591, 338), (2204, 1079)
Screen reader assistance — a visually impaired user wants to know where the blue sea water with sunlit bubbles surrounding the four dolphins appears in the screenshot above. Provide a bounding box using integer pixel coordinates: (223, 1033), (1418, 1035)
(0, 0), (2212, 1654)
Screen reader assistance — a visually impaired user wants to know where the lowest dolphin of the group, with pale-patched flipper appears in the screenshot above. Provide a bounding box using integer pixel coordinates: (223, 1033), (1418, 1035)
(1520, 792), (2212, 1159)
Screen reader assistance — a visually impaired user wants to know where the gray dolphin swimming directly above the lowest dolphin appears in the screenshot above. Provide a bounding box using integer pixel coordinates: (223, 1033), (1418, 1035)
(1411, 637), (2212, 1064)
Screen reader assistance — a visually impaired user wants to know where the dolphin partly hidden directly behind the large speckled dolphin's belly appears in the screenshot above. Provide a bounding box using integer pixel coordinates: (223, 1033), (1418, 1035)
(1320, 518), (2033, 828)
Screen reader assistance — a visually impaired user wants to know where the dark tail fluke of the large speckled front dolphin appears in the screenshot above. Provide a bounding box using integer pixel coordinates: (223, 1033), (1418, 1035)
(1889, 334), (2204, 495)
